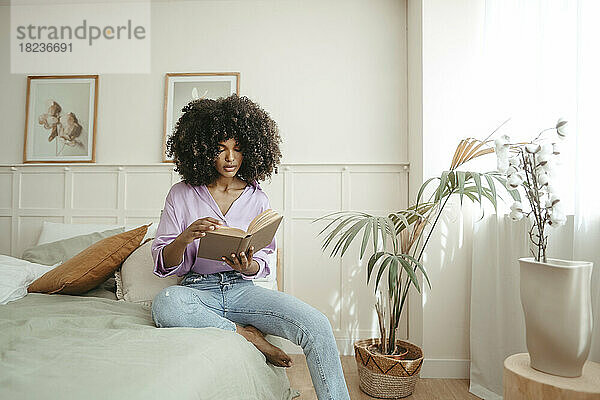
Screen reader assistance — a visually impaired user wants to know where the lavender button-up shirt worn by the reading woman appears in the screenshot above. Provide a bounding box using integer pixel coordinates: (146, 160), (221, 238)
(152, 182), (276, 280)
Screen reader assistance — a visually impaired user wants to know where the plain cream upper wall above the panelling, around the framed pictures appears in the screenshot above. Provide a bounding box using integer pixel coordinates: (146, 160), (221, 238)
(0, 0), (407, 164)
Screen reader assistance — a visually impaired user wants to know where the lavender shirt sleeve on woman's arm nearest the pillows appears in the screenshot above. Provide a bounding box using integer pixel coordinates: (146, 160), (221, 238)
(151, 192), (189, 278)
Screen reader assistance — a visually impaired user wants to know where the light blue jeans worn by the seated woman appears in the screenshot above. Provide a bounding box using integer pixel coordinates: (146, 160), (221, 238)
(152, 271), (350, 400)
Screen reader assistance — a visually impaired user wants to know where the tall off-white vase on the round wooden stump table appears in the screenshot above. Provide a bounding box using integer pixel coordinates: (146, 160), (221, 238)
(519, 257), (593, 377)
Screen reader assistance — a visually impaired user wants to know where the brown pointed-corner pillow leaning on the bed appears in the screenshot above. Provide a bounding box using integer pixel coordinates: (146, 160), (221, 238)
(27, 224), (151, 294)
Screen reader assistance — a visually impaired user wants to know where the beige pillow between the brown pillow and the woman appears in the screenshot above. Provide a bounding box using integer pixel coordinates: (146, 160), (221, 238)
(115, 239), (183, 307)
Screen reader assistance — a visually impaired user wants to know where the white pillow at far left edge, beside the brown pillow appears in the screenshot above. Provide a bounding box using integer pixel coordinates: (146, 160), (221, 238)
(0, 254), (61, 304)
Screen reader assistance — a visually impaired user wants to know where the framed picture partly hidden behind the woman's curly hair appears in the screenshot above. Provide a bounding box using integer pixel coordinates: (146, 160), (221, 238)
(163, 72), (240, 162)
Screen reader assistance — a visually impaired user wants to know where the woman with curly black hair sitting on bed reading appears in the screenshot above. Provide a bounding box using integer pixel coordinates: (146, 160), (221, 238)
(152, 95), (350, 400)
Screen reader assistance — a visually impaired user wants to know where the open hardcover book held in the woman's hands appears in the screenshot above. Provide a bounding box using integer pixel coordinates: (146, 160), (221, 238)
(196, 208), (283, 261)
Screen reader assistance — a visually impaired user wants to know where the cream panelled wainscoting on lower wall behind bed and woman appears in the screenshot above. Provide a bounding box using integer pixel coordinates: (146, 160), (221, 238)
(0, 163), (408, 354)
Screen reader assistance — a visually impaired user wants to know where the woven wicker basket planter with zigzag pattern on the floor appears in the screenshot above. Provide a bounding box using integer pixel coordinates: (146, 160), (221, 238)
(354, 339), (423, 399)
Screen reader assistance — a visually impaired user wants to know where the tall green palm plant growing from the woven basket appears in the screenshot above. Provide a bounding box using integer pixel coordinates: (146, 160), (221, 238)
(313, 124), (520, 355)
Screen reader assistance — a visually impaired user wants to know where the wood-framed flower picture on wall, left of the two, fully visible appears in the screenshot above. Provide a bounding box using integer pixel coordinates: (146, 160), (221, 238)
(23, 75), (98, 163)
